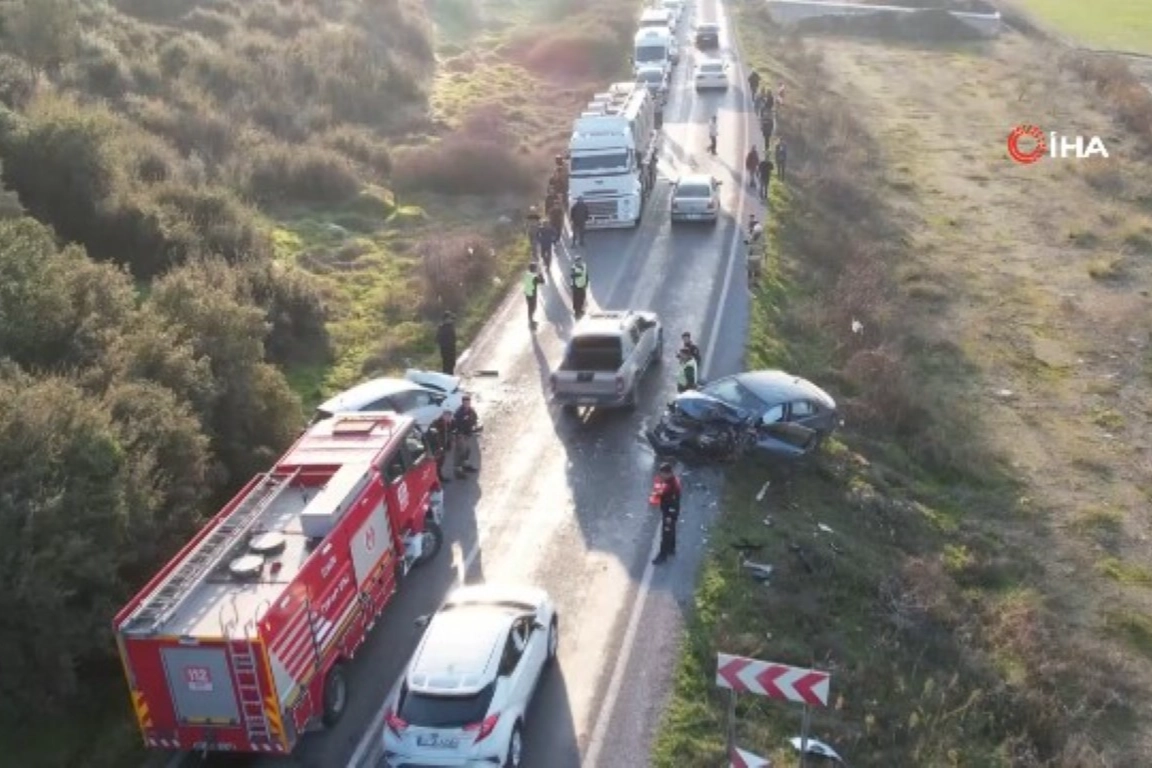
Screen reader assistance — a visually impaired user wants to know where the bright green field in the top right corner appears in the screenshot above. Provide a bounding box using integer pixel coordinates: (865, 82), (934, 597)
(1015, 0), (1152, 54)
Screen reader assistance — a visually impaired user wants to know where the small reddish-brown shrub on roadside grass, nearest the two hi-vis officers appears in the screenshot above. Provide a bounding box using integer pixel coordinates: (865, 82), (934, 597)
(416, 235), (497, 318)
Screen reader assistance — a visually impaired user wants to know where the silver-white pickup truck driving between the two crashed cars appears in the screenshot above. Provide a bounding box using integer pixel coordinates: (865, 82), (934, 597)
(552, 311), (664, 410)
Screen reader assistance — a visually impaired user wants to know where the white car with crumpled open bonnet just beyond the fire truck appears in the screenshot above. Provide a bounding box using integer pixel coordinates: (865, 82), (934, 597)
(312, 368), (464, 429)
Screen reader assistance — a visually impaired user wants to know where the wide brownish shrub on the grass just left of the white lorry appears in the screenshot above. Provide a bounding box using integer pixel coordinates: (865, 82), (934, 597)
(394, 134), (539, 196)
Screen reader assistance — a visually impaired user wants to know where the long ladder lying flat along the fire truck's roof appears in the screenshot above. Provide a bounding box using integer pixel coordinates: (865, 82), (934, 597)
(126, 469), (300, 633)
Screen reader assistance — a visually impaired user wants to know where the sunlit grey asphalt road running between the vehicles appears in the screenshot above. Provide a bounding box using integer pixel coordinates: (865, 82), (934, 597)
(160, 0), (763, 768)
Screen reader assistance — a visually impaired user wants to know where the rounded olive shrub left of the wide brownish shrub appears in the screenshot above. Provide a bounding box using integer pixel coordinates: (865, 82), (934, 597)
(244, 143), (361, 204)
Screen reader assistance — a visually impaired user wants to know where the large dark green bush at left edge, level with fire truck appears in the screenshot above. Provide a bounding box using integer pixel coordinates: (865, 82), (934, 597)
(0, 370), (128, 716)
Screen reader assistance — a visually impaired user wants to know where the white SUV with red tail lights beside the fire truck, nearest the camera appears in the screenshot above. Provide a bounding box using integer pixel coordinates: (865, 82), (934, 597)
(384, 585), (560, 768)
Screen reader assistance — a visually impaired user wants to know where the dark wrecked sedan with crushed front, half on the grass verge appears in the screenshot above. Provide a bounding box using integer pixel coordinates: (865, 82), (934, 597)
(647, 371), (841, 459)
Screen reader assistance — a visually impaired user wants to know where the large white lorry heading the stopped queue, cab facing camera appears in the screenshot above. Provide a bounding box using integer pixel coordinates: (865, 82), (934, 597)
(568, 83), (660, 229)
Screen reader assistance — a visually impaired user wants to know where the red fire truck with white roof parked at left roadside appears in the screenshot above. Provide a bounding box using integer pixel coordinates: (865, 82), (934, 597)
(114, 413), (444, 753)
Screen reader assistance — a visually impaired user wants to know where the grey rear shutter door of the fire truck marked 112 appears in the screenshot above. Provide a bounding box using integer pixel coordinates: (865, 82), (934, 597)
(160, 647), (240, 724)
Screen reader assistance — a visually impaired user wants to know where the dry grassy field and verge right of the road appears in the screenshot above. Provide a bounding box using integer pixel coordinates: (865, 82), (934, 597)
(654, 2), (1152, 768)
